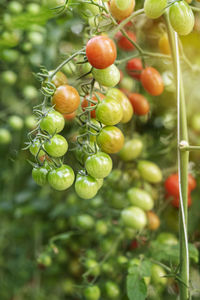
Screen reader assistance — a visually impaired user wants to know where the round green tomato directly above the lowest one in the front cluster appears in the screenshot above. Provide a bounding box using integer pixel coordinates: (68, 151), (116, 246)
(85, 152), (112, 179)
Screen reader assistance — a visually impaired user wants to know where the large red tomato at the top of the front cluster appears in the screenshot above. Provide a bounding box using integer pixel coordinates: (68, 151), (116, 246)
(86, 35), (117, 69)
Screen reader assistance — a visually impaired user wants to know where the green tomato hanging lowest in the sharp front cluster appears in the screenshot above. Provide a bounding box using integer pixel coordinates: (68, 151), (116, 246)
(75, 175), (99, 199)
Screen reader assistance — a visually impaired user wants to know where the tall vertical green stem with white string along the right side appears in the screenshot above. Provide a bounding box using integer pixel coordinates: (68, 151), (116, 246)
(166, 15), (189, 300)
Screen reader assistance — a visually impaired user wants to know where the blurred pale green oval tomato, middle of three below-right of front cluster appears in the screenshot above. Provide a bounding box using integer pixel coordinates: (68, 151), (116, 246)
(127, 188), (154, 211)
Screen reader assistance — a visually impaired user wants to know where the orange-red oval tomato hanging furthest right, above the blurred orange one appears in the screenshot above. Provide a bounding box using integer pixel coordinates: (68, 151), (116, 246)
(141, 67), (164, 96)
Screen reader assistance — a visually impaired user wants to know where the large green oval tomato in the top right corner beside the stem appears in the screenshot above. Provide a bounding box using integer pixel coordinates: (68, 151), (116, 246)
(169, 1), (194, 35)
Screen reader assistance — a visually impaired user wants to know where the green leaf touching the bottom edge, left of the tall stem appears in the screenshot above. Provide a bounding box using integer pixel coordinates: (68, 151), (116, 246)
(126, 272), (147, 300)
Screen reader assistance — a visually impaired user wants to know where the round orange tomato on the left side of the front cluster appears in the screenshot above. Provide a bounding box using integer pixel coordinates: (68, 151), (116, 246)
(52, 85), (80, 114)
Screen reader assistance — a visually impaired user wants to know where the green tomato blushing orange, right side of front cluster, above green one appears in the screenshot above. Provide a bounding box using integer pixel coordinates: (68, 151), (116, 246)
(97, 126), (124, 153)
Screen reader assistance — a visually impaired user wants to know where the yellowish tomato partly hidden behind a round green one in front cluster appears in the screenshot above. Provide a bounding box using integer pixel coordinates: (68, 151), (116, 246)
(106, 88), (133, 124)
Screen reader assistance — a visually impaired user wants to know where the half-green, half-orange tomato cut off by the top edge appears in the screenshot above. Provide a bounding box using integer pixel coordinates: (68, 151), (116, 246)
(109, 0), (135, 21)
